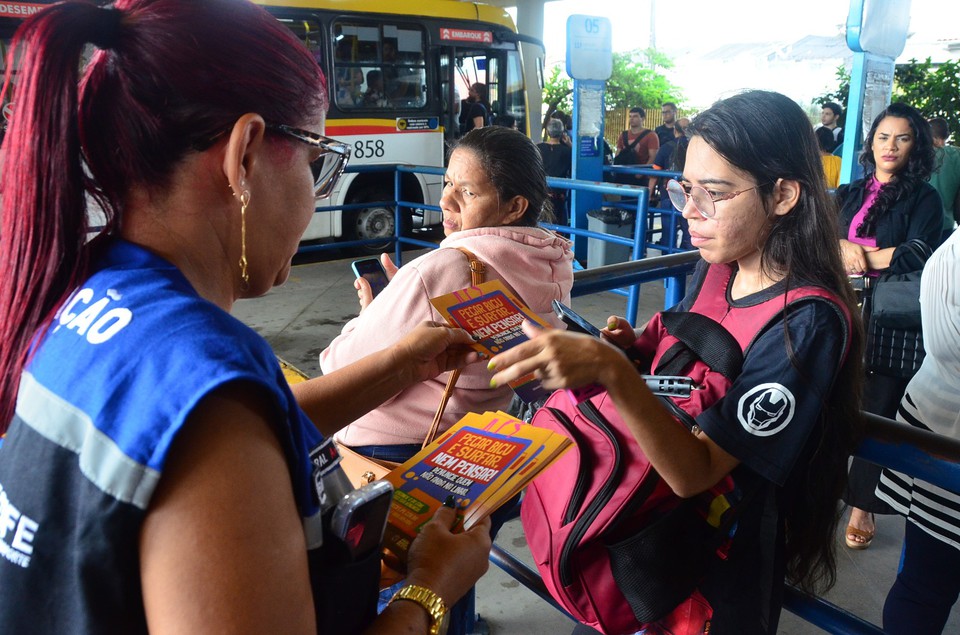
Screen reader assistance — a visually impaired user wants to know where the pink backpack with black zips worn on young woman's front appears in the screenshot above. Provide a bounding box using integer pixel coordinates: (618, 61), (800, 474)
(521, 265), (841, 635)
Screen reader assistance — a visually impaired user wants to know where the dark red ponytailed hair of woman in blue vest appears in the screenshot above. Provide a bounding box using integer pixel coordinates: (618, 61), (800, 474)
(0, 0), (327, 431)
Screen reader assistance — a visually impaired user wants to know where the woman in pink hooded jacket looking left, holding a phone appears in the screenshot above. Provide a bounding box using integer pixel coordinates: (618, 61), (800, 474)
(320, 126), (573, 461)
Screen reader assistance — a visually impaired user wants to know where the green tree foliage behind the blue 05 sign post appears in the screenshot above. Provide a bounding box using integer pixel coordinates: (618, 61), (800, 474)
(543, 49), (682, 130)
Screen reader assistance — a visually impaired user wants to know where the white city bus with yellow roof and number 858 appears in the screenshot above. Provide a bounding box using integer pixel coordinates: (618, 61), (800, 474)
(0, 0), (543, 251)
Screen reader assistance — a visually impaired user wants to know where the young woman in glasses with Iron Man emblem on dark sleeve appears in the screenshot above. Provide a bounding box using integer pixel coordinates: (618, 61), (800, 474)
(489, 91), (862, 635)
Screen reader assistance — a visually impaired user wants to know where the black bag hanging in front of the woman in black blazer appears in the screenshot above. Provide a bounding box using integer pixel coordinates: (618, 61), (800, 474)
(863, 239), (932, 379)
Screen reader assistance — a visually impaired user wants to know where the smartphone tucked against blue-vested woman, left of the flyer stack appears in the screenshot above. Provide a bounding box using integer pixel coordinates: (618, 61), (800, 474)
(330, 481), (393, 561)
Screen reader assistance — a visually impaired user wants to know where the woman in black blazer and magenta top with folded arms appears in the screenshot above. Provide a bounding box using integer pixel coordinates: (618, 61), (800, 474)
(837, 103), (943, 550)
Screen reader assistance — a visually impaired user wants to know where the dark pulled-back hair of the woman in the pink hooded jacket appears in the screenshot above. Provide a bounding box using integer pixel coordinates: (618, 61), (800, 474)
(450, 126), (553, 227)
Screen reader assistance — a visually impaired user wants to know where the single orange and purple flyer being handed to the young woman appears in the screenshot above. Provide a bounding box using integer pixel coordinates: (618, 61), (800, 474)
(430, 280), (550, 403)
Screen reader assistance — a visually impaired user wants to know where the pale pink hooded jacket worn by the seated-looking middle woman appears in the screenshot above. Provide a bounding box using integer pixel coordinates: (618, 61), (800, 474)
(320, 226), (573, 446)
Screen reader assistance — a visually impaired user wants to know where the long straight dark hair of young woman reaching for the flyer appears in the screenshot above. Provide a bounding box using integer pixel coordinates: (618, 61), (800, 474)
(688, 91), (863, 591)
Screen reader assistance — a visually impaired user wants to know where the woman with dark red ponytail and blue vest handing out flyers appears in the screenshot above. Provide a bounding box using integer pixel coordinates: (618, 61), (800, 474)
(0, 0), (490, 634)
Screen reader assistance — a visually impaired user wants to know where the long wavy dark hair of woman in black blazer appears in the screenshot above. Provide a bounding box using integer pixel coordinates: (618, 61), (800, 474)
(857, 103), (936, 237)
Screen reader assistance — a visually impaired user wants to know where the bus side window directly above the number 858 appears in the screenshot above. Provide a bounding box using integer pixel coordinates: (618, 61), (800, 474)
(333, 21), (428, 110)
